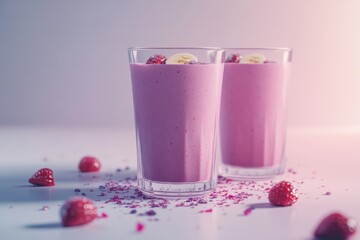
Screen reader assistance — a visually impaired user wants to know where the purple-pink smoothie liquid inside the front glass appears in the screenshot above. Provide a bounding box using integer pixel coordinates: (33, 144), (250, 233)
(130, 64), (223, 182)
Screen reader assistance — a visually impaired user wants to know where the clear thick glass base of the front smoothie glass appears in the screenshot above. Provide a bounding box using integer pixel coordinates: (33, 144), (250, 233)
(138, 178), (216, 198)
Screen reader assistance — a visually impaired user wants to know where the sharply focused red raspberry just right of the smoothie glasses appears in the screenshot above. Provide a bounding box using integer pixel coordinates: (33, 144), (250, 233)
(269, 181), (298, 206)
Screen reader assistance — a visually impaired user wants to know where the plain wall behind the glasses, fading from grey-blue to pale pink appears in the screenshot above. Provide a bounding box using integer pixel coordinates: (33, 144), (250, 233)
(0, 0), (360, 127)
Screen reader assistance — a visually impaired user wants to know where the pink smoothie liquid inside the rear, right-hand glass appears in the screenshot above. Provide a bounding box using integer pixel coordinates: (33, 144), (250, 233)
(220, 63), (289, 168)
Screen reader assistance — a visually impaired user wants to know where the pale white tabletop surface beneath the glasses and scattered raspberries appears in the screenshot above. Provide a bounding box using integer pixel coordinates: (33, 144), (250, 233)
(0, 127), (360, 240)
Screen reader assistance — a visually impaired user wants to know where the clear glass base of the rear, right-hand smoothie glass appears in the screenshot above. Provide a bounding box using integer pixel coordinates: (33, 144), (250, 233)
(220, 163), (285, 179)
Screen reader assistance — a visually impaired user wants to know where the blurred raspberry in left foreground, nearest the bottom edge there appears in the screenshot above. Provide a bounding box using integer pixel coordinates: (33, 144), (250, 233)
(60, 197), (97, 227)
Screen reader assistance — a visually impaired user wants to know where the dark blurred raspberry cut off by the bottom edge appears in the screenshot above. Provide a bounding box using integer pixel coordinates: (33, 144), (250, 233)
(314, 212), (356, 240)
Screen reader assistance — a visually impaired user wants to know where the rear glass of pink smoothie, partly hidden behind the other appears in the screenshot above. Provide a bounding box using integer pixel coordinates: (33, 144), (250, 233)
(220, 48), (292, 179)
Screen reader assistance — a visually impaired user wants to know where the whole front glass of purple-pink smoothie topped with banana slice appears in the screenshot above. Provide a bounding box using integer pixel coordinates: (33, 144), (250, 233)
(128, 48), (225, 197)
